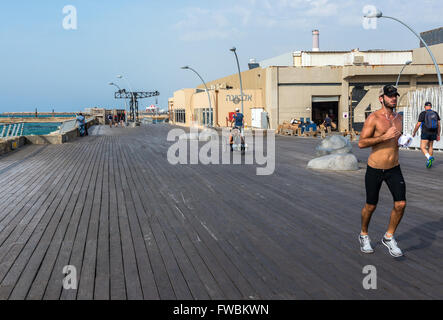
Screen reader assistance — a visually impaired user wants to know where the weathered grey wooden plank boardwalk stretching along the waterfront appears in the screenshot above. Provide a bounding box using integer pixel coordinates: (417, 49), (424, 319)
(0, 125), (443, 300)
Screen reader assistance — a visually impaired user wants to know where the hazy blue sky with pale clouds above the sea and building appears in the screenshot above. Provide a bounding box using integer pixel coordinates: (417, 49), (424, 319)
(0, 0), (443, 112)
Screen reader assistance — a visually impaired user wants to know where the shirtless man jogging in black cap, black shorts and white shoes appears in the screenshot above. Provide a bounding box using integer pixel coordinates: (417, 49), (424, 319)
(358, 85), (406, 257)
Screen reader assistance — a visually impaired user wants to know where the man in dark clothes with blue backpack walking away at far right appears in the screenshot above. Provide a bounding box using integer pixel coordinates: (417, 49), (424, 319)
(412, 102), (441, 168)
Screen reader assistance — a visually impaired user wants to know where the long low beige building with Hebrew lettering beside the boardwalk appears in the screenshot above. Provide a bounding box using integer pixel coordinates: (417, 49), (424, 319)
(169, 44), (443, 131)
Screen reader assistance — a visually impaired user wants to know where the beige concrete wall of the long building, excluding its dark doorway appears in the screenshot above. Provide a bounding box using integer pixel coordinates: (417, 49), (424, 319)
(170, 44), (443, 131)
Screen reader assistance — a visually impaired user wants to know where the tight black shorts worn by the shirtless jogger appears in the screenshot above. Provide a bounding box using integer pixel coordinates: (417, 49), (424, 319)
(365, 166), (406, 205)
